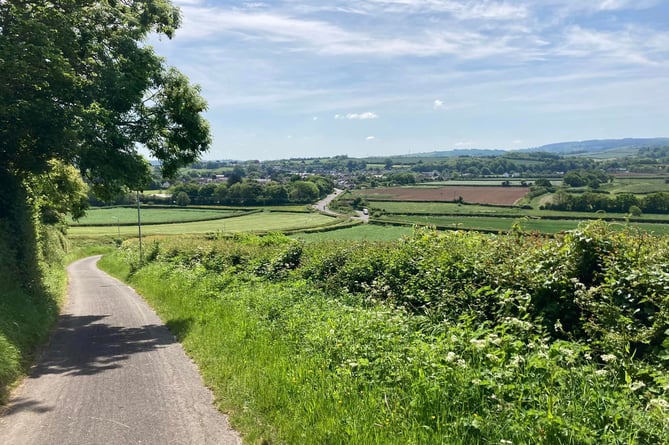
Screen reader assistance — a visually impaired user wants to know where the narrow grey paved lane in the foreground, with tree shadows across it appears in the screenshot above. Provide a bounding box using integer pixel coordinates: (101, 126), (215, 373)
(0, 257), (241, 445)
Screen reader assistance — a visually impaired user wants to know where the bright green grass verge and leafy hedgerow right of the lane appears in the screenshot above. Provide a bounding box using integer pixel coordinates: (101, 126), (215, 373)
(100, 227), (669, 445)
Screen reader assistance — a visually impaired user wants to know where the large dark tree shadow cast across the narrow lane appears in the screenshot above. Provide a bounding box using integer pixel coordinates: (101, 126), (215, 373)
(30, 315), (175, 378)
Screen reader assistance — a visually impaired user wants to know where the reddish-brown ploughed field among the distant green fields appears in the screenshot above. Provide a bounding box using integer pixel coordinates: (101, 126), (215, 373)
(356, 186), (529, 205)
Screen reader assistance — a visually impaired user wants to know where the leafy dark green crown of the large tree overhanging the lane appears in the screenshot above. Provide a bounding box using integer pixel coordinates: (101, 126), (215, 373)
(0, 0), (210, 205)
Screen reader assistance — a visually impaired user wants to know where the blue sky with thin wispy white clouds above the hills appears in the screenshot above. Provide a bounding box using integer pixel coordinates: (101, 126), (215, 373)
(149, 0), (669, 160)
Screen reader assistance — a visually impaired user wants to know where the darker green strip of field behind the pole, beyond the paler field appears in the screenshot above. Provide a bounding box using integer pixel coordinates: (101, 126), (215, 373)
(70, 207), (242, 226)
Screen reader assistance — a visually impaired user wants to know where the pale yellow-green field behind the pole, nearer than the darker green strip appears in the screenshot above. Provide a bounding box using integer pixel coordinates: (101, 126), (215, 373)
(68, 212), (338, 238)
